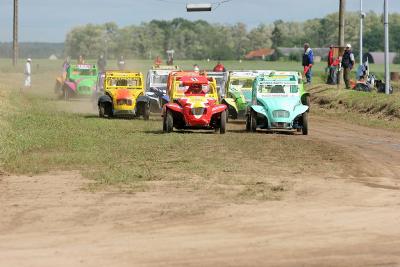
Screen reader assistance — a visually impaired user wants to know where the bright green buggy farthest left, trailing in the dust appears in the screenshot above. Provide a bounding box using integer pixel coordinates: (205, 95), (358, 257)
(56, 64), (98, 100)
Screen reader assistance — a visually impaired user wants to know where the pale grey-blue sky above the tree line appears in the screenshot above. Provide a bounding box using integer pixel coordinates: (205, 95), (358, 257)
(0, 0), (400, 42)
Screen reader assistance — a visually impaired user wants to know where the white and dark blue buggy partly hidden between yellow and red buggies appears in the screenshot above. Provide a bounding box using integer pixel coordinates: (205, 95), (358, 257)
(146, 65), (179, 113)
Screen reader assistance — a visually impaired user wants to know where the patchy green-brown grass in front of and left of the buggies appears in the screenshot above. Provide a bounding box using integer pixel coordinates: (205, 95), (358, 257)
(0, 61), (360, 199)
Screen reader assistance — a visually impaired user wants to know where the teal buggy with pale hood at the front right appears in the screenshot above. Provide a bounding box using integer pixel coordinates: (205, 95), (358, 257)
(246, 71), (309, 135)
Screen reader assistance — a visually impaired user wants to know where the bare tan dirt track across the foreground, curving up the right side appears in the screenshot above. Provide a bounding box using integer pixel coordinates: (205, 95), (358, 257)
(0, 117), (400, 267)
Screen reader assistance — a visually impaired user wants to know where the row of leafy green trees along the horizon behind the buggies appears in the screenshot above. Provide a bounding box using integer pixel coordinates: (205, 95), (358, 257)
(65, 12), (400, 59)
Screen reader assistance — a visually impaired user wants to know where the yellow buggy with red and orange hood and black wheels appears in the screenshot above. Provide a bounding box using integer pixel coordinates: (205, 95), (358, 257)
(97, 71), (150, 120)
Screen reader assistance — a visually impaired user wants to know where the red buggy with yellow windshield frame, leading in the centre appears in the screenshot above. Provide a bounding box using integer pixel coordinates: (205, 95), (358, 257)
(162, 73), (227, 134)
